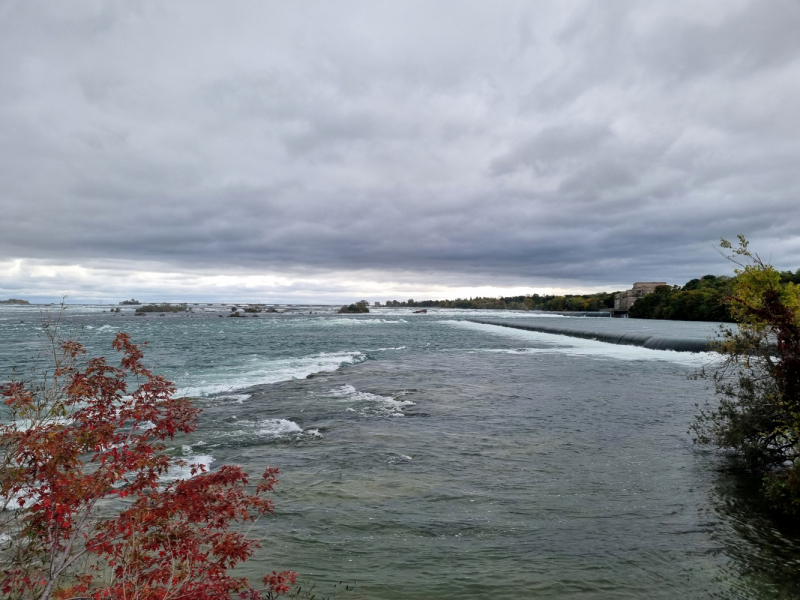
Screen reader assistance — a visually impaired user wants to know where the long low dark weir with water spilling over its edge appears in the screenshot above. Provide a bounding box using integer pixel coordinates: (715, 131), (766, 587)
(469, 319), (712, 352)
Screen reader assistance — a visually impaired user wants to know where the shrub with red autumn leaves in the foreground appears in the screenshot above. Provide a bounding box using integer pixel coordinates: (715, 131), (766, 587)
(0, 324), (297, 600)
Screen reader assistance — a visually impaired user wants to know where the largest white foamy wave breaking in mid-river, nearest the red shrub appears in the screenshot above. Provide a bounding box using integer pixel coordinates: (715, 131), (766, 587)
(177, 351), (367, 398)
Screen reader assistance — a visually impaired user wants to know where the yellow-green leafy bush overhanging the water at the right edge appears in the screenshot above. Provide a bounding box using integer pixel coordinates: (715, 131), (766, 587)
(691, 236), (800, 518)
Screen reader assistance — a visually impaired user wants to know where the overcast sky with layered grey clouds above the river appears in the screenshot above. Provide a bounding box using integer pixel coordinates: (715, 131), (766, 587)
(0, 0), (800, 302)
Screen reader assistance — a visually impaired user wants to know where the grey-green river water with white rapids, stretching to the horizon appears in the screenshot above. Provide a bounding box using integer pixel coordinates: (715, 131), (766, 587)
(0, 306), (800, 599)
